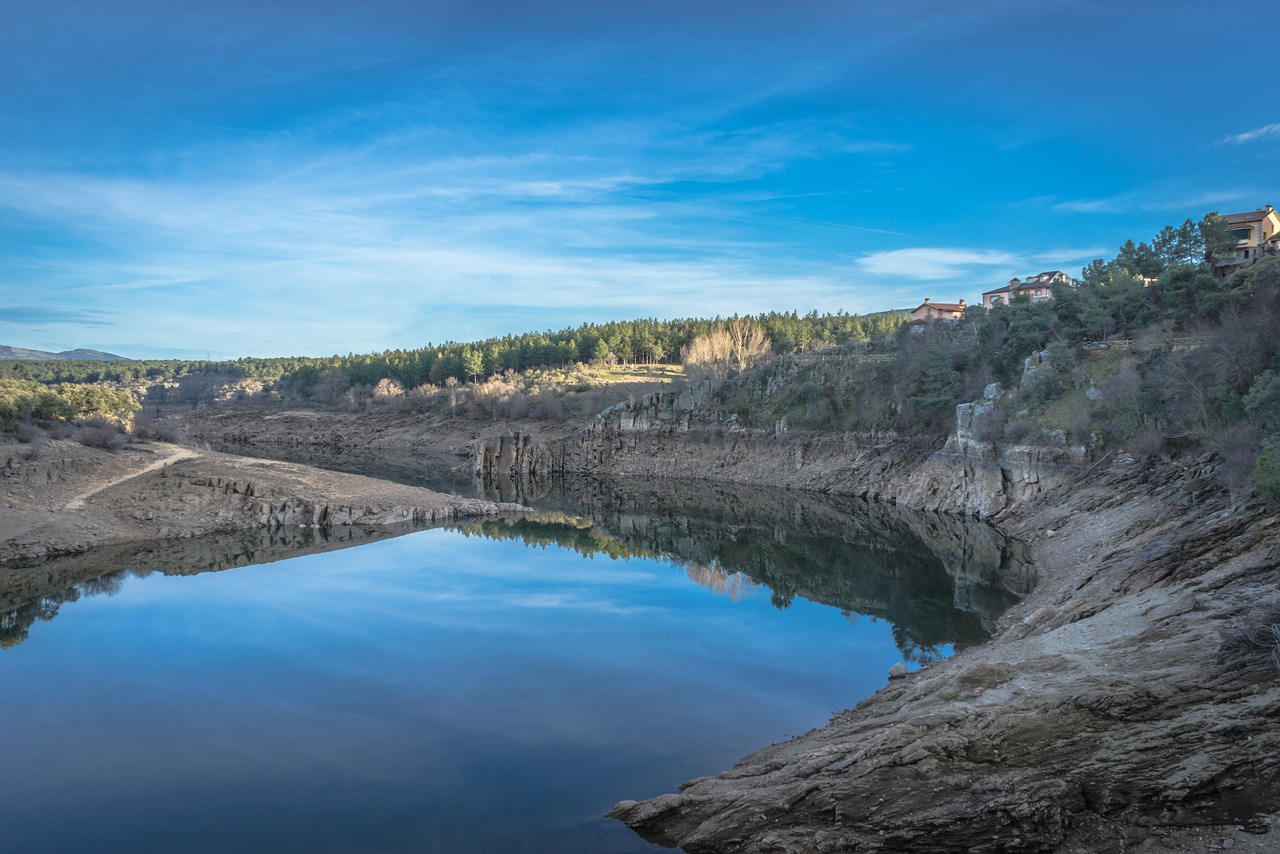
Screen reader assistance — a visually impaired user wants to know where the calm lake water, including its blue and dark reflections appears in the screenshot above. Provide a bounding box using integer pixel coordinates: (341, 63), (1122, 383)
(0, 485), (1030, 853)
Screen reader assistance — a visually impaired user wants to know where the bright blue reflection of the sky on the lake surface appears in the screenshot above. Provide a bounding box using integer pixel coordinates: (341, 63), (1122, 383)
(0, 530), (916, 853)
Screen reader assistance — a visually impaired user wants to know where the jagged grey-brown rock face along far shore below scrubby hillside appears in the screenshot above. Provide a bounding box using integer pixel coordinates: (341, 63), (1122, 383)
(474, 381), (1085, 519)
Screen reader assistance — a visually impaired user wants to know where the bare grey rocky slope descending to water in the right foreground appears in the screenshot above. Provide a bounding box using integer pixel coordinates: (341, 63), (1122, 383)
(611, 461), (1280, 854)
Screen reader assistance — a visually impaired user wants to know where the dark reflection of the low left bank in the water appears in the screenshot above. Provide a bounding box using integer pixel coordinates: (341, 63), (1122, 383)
(0, 525), (409, 649)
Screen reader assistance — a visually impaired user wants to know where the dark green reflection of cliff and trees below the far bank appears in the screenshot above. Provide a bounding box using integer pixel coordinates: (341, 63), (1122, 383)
(456, 480), (1034, 662)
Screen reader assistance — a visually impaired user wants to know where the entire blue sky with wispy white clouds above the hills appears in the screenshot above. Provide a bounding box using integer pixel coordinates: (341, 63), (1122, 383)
(0, 0), (1280, 359)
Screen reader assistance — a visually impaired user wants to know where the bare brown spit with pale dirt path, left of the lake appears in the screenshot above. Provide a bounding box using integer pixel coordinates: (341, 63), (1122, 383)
(0, 440), (524, 565)
